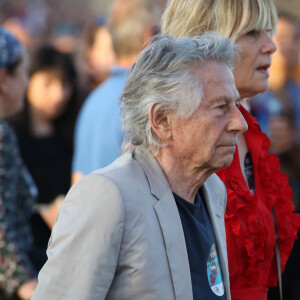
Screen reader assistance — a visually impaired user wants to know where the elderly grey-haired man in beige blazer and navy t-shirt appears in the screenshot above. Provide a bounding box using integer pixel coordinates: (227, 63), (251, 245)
(32, 33), (247, 300)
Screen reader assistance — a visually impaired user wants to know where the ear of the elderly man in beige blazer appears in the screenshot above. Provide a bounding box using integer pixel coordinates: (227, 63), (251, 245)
(148, 104), (172, 142)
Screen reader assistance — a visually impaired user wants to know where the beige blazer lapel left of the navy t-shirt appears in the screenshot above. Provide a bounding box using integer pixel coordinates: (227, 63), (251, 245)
(134, 148), (193, 300)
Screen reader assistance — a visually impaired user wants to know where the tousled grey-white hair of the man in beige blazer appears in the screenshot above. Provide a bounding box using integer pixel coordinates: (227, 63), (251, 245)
(120, 32), (237, 150)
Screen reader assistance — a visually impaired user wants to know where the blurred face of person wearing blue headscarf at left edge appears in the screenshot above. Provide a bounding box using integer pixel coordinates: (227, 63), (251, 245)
(0, 53), (28, 118)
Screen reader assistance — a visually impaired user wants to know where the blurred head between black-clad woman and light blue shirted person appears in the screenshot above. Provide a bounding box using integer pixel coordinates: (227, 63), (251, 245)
(77, 15), (116, 93)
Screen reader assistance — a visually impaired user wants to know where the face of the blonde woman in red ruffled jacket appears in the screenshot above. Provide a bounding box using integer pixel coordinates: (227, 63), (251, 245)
(233, 29), (276, 98)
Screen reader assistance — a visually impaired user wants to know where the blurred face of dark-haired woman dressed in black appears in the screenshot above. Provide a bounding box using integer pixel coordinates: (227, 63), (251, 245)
(27, 69), (72, 121)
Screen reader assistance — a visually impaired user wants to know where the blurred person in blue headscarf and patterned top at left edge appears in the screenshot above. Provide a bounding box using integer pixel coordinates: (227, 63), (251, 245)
(0, 27), (37, 300)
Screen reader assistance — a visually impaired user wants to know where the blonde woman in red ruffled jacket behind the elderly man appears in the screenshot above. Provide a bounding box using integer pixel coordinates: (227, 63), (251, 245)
(161, 0), (300, 300)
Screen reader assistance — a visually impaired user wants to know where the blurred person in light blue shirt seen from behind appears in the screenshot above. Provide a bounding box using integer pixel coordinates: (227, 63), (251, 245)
(72, 0), (161, 183)
